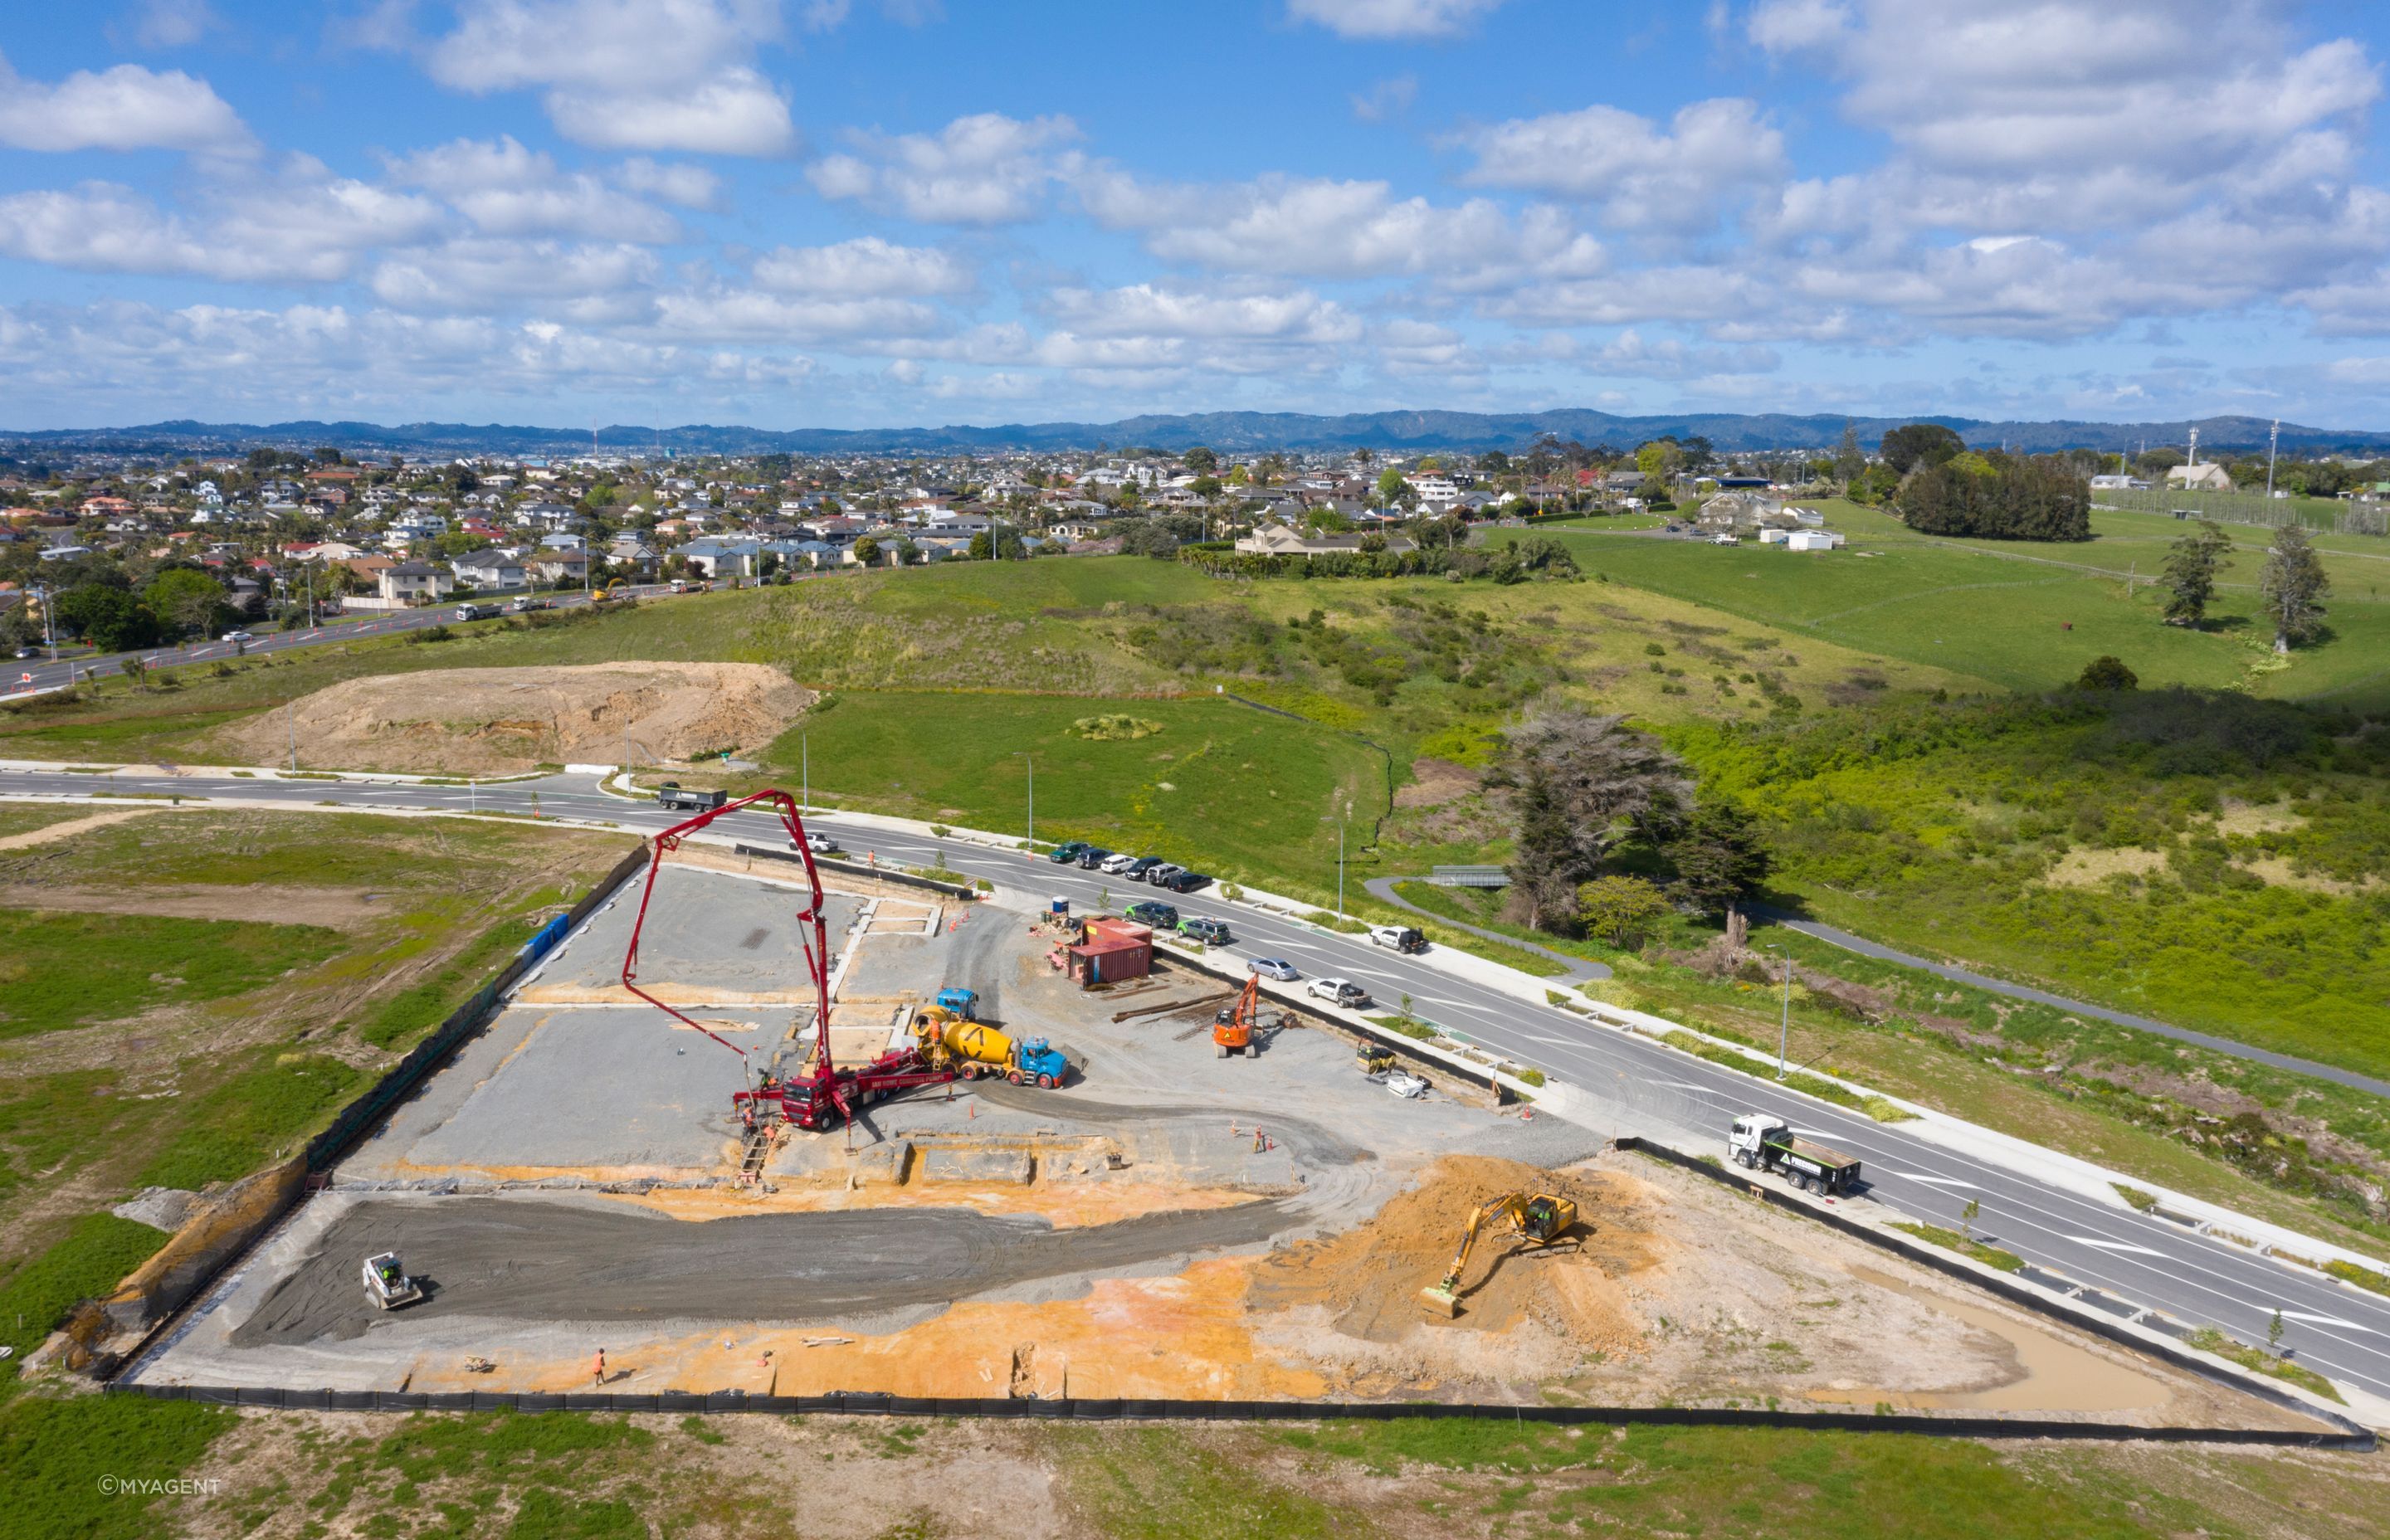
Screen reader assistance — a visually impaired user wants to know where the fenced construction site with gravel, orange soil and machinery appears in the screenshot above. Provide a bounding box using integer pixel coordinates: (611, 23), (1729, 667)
(127, 813), (2332, 1428)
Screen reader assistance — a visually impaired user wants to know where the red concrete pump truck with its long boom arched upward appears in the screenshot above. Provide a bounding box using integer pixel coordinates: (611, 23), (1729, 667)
(622, 789), (954, 1133)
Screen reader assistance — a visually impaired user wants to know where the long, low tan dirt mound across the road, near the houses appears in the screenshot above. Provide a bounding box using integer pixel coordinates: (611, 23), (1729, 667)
(212, 662), (812, 775)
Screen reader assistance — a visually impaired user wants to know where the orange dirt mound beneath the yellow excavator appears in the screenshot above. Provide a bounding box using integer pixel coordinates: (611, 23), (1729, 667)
(1247, 1155), (1661, 1351)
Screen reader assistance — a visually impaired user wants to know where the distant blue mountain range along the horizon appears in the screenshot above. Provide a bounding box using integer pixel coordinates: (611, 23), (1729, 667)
(0, 409), (2390, 459)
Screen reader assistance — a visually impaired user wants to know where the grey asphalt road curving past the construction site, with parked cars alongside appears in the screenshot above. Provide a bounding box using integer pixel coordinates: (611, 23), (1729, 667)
(0, 770), (2390, 1396)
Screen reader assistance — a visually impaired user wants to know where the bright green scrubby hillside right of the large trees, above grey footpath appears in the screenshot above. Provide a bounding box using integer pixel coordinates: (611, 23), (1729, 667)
(1671, 691), (2390, 1076)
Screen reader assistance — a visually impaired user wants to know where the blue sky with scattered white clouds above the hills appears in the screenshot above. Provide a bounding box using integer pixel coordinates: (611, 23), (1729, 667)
(0, 0), (2390, 428)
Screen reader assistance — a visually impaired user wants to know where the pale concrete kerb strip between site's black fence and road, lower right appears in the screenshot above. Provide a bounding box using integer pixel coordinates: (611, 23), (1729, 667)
(1616, 1136), (2390, 1451)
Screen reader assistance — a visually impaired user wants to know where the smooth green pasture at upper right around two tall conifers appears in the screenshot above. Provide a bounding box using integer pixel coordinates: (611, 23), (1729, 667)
(1504, 502), (2390, 705)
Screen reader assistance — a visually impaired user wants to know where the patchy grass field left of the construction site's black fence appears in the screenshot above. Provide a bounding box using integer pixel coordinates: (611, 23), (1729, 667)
(0, 808), (628, 1367)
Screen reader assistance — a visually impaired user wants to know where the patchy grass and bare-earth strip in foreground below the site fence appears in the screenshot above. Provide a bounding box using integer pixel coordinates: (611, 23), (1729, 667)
(13, 1394), (2385, 1540)
